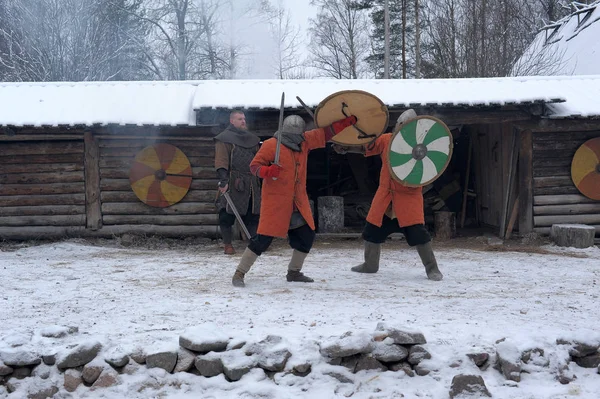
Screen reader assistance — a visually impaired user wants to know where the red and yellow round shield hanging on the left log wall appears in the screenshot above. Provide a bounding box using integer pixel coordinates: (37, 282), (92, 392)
(129, 143), (192, 208)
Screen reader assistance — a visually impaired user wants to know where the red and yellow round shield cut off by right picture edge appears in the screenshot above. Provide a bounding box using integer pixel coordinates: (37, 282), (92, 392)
(571, 137), (600, 200)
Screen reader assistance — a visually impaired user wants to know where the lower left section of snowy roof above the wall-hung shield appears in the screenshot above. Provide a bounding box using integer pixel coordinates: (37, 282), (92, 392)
(0, 81), (197, 126)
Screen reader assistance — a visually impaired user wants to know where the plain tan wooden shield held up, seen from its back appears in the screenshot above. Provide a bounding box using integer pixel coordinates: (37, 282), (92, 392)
(315, 90), (389, 145)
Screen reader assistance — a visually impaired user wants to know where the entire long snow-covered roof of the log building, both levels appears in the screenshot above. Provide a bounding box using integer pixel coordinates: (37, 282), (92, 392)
(0, 75), (600, 126)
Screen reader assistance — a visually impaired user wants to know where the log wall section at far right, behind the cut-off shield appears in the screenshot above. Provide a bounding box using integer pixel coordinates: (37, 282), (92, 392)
(533, 130), (600, 237)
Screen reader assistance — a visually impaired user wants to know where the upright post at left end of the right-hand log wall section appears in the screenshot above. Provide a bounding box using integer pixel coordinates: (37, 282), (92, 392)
(519, 130), (533, 234)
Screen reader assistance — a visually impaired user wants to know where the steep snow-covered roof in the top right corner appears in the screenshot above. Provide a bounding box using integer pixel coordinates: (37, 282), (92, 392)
(513, 1), (600, 75)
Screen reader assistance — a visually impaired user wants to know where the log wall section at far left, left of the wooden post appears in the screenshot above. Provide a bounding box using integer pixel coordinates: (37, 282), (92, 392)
(0, 141), (86, 234)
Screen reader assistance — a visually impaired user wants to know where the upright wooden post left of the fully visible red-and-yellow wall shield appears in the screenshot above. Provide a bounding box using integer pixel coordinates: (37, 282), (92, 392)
(83, 130), (102, 230)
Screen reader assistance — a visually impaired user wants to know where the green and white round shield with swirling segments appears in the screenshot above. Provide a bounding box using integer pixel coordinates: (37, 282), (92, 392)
(388, 115), (453, 187)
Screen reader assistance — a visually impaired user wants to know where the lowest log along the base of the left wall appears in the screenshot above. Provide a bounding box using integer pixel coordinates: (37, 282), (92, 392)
(0, 225), (219, 240)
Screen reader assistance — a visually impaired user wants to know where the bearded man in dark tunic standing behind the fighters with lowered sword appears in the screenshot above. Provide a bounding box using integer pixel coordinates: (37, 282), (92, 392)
(215, 110), (260, 255)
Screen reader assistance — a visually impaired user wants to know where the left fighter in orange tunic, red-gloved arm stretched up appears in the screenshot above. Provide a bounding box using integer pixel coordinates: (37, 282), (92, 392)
(231, 115), (356, 287)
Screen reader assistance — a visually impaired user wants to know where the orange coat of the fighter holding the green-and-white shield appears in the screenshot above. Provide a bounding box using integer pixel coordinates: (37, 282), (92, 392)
(365, 133), (425, 227)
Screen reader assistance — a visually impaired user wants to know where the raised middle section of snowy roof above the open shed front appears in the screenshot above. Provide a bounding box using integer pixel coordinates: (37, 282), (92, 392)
(193, 78), (564, 109)
